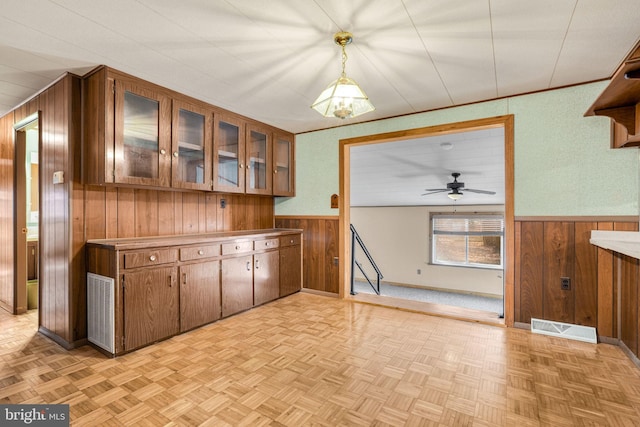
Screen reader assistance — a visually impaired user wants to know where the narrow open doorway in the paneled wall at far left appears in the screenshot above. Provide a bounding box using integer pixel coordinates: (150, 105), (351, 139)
(14, 114), (40, 314)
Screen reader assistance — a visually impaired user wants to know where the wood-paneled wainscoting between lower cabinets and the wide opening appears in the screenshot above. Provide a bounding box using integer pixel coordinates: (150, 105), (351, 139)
(276, 216), (341, 294)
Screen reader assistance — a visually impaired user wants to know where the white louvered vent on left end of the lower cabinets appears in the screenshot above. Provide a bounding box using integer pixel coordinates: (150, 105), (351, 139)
(87, 273), (115, 353)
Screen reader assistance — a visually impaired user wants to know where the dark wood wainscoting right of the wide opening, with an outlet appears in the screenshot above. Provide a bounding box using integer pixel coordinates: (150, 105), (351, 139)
(514, 217), (640, 362)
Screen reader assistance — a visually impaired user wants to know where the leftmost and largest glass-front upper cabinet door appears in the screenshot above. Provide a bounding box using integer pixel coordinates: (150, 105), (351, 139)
(114, 81), (171, 186)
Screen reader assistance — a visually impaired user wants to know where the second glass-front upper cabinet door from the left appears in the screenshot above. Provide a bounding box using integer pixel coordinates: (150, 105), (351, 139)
(171, 100), (213, 190)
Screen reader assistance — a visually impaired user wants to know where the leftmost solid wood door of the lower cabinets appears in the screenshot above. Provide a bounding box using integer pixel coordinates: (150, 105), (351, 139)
(123, 267), (180, 351)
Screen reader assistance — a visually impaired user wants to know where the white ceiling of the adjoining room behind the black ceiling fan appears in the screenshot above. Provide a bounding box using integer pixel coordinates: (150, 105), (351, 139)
(350, 128), (505, 206)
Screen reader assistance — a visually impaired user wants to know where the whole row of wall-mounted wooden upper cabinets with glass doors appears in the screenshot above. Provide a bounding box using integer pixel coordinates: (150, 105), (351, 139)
(82, 66), (295, 196)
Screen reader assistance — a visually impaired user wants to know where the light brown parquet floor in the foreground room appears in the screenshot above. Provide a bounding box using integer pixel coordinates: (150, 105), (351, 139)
(0, 293), (640, 427)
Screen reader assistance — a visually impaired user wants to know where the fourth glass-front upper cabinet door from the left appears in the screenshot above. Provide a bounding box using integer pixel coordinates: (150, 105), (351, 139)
(245, 125), (273, 194)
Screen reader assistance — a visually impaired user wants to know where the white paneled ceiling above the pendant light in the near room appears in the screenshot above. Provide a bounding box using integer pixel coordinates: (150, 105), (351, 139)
(0, 0), (640, 133)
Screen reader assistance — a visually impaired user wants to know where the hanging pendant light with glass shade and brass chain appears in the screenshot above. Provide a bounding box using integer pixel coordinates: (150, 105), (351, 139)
(311, 31), (375, 119)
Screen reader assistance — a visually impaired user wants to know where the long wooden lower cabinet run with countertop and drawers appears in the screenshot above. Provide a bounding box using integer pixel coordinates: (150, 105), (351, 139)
(86, 229), (302, 356)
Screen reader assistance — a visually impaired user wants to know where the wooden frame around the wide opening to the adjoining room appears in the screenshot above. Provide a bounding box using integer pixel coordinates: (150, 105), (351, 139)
(338, 114), (515, 326)
